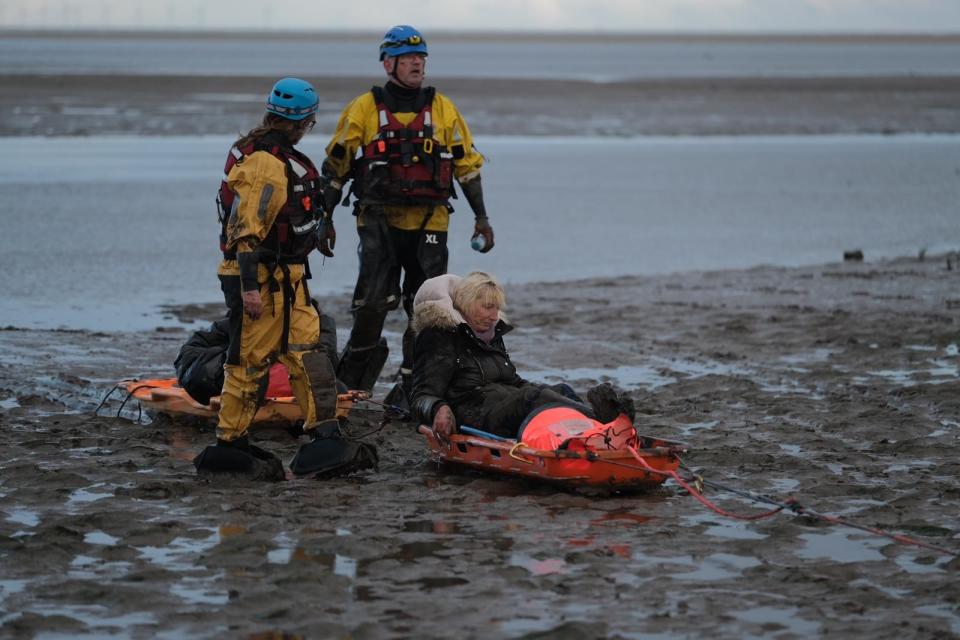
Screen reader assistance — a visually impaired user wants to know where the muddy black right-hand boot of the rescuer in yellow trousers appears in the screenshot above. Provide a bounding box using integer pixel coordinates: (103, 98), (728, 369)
(290, 420), (380, 480)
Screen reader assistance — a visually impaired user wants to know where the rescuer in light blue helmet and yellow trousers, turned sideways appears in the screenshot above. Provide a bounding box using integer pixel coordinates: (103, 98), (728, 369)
(194, 78), (372, 480)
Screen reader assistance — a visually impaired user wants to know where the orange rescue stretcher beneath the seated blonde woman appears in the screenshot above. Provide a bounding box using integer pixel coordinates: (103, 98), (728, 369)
(419, 425), (687, 489)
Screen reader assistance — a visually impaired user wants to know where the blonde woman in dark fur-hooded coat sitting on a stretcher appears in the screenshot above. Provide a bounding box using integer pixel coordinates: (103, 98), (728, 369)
(411, 271), (635, 439)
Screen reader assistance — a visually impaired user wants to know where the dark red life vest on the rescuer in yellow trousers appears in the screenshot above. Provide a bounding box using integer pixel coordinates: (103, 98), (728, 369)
(217, 139), (323, 264)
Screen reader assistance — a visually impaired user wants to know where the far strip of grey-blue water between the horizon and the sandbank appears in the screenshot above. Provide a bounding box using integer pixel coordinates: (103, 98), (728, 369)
(0, 32), (960, 82)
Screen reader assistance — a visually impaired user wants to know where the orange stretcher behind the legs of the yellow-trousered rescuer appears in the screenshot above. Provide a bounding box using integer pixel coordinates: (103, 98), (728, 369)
(117, 378), (369, 425)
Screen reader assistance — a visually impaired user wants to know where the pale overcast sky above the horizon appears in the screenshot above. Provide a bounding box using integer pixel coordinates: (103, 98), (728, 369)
(0, 0), (960, 33)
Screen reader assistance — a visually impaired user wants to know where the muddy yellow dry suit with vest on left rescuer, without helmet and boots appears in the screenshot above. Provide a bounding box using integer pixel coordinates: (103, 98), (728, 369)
(217, 138), (336, 441)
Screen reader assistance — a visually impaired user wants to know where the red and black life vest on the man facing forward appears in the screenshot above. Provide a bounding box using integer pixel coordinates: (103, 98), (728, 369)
(354, 87), (464, 204)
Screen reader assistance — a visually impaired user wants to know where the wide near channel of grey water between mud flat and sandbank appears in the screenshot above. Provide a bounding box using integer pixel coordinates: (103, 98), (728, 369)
(0, 132), (960, 330)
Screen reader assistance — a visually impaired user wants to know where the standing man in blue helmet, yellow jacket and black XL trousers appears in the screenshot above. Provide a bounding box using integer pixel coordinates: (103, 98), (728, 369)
(321, 25), (494, 402)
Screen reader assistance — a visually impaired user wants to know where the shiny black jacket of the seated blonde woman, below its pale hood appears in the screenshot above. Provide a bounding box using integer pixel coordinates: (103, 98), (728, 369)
(412, 320), (529, 428)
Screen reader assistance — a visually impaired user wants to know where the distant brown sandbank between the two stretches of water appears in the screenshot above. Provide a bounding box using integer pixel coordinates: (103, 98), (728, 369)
(0, 75), (960, 136)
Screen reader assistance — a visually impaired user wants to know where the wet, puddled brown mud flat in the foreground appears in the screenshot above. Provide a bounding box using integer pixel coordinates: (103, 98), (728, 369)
(0, 258), (960, 638)
